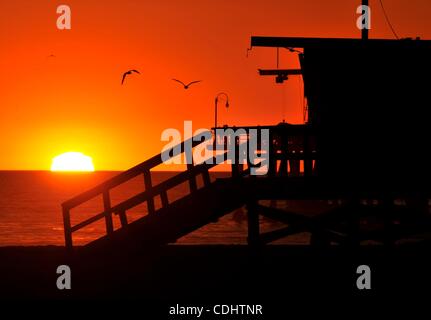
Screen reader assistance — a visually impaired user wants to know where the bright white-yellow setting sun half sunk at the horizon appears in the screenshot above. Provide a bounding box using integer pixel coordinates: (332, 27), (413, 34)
(51, 152), (94, 172)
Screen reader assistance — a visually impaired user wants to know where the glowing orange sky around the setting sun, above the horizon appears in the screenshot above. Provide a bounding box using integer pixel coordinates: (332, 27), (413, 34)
(0, 0), (431, 170)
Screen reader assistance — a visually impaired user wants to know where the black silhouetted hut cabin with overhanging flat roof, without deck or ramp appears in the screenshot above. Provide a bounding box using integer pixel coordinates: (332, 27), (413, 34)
(252, 37), (431, 194)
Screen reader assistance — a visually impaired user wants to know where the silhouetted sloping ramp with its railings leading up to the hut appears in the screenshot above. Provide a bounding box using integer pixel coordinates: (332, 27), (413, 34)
(62, 132), (251, 249)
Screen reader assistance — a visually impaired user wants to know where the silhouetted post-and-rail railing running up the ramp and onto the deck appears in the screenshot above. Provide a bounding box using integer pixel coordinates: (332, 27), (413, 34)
(62, 126), (316, 249)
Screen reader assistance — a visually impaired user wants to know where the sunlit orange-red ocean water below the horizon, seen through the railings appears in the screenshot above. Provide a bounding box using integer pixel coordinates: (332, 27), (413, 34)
(0, 171), (309, 246)
